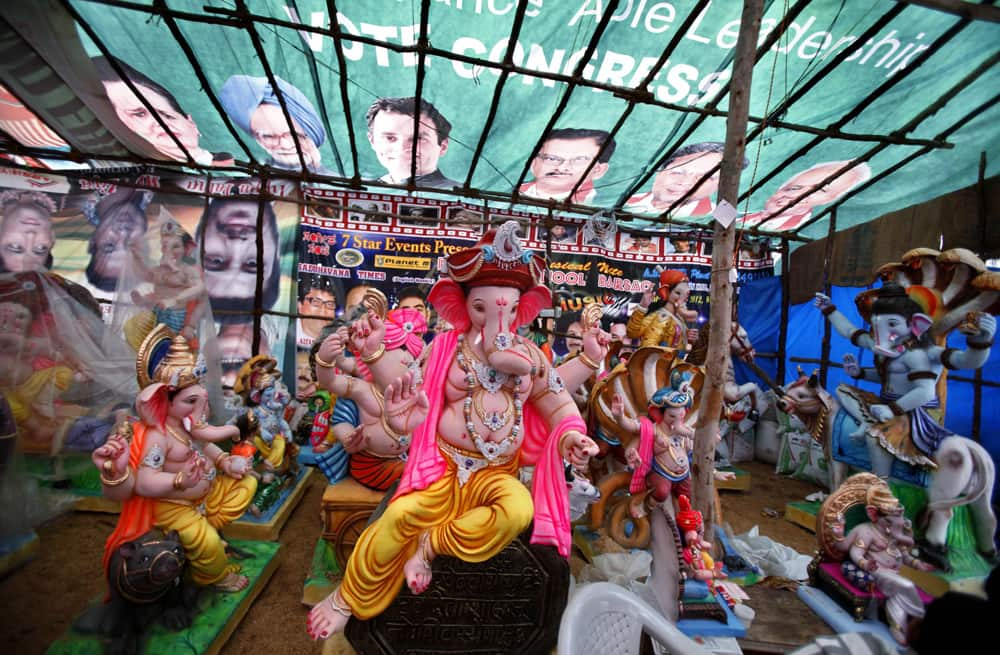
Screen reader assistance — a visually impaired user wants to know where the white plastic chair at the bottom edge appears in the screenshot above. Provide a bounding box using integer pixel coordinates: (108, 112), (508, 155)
(559, 582), (711, 655)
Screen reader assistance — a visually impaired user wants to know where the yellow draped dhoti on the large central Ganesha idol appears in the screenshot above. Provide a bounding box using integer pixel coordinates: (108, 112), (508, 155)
(340, 440), (534, 619)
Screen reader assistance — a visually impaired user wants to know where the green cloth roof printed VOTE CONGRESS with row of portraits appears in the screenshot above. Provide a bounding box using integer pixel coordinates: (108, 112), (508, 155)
(0, 0), (1000, 240)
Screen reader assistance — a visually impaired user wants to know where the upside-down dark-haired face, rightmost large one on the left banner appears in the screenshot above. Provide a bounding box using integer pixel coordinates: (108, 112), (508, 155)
(201, 200), (278, 298)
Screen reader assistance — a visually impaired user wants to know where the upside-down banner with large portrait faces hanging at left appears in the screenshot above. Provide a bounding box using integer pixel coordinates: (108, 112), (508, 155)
(0, 169), (298, 394)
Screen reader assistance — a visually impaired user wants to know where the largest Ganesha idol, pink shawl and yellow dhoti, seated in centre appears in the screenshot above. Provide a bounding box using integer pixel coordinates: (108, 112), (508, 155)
(308, 221), (597, 638)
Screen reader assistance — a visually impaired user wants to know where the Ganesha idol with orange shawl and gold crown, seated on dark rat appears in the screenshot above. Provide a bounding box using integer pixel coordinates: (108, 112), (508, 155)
(91, 324), (257, 592)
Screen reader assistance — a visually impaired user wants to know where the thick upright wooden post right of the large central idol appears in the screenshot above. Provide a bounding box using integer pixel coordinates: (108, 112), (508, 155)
(691, 0), (763, 540)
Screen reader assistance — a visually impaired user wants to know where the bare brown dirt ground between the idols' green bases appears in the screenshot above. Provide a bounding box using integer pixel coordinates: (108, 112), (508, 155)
(0, 462), (818, 655)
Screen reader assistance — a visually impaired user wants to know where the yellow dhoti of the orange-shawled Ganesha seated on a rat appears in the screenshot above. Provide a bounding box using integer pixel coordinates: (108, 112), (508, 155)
(153, 475), (257, 585)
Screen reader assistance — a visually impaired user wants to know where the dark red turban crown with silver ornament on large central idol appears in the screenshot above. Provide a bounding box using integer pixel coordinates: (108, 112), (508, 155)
(446, 221), (545, 291)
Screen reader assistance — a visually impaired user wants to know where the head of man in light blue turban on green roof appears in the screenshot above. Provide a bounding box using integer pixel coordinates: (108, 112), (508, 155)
(219, 75), (333, 175)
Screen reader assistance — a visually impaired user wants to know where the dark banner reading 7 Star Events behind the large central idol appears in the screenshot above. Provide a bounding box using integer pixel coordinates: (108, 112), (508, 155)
(296, 189), (773, 366)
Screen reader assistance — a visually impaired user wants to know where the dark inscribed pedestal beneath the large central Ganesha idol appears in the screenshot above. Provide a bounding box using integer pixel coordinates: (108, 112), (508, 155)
(347, 529), (569, 655)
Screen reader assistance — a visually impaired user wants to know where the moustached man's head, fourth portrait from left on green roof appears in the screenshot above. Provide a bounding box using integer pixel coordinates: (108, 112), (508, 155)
(518, 128), (615, 205)
